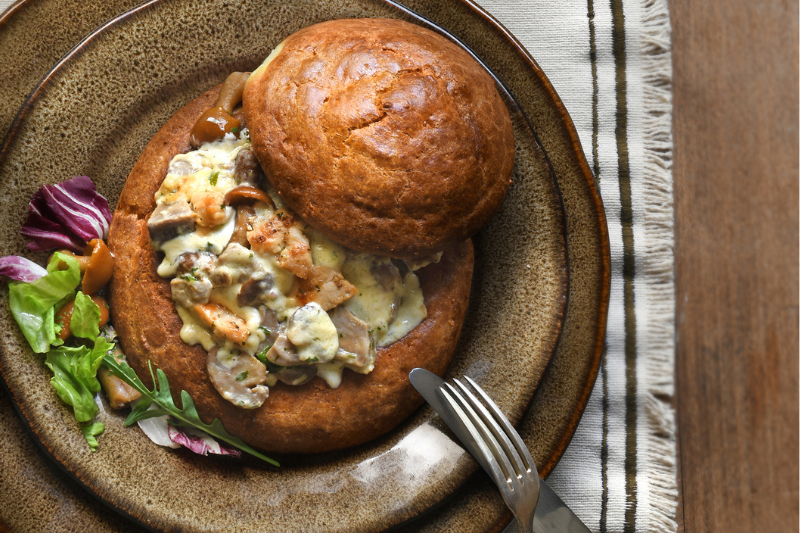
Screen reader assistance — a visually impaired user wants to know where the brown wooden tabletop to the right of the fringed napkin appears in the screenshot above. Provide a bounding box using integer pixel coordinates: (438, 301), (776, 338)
(670, 0), (798, 532)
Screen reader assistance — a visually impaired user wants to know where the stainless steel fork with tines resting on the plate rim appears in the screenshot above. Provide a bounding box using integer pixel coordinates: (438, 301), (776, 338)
(440, 377), (539, 533)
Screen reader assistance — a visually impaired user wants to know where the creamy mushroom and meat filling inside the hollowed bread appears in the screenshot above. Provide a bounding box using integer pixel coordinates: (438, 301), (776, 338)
(148, 133), (432, 408)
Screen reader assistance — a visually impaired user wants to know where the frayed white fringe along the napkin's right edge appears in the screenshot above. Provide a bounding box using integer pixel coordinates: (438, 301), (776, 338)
(636, 0), (678, 533)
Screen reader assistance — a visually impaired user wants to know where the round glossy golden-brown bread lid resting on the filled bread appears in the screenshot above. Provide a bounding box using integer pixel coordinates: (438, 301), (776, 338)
(243, 19), (514, 258)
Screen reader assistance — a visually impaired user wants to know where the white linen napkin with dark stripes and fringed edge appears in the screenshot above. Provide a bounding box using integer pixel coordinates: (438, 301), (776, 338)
(478, 0), (678, 533)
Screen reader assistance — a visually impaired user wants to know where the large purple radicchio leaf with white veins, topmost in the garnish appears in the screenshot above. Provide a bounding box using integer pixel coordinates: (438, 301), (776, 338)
(20, 176), (111, 252)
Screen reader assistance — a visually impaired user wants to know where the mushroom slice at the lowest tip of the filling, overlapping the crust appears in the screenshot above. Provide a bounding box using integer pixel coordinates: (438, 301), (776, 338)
(206, 346), (269, 409)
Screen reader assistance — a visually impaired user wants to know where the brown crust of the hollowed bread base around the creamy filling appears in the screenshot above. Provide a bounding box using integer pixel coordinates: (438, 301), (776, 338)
(108, 88), (473, 453)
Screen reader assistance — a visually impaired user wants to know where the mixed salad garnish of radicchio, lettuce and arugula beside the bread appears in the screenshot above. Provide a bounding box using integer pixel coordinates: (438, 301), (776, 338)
(0, 176), (279, 466)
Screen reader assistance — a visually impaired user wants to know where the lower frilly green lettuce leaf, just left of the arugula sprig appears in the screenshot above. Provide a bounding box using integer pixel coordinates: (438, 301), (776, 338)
(45, 337), (114, 422)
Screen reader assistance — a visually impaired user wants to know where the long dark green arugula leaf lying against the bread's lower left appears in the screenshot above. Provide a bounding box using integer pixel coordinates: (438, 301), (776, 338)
(104, 354), (280, 466)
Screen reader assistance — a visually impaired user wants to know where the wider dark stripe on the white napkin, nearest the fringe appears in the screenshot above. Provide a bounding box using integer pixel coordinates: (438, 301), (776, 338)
(611, 0), (637, 533)
